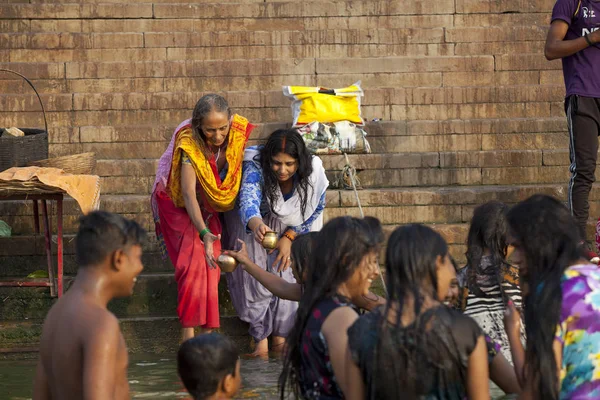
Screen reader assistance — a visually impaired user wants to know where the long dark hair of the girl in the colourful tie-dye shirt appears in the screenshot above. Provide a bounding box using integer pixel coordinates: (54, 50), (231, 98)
(508, 195), (582, 400)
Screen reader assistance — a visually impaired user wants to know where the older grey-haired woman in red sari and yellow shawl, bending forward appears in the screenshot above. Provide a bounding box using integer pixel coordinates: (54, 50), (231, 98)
(152, 94), (254, 340)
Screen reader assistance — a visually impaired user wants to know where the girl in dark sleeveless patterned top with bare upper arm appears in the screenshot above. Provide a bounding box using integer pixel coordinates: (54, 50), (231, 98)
(280, 217), (383, 399)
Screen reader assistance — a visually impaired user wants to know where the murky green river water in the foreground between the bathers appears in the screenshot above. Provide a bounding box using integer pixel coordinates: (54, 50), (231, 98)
(0, 354), (510, 400)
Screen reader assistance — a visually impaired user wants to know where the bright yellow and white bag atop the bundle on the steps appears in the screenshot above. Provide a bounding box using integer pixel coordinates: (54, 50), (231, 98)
(283, 81), (364, 126)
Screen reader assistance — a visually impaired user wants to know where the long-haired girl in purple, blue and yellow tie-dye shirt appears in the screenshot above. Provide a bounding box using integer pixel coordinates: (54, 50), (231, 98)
(505, 195), (600, 400)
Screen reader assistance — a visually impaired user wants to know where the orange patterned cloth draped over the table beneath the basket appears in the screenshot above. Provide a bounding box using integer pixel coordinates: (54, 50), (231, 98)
(0, 167), (100, 214)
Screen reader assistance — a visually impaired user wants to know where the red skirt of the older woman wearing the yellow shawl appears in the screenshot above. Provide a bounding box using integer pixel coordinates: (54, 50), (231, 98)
(155, 190), (223, 328)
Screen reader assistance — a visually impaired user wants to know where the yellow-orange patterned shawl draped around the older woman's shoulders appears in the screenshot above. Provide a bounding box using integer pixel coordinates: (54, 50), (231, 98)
(167, 114), (254, 212)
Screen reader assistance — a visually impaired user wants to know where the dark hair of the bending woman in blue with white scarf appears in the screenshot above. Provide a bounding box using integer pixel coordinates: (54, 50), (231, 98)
(260, 129), (313, 217)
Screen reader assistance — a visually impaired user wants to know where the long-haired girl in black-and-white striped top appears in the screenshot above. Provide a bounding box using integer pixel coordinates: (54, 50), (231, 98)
(457, 201), (524, 363)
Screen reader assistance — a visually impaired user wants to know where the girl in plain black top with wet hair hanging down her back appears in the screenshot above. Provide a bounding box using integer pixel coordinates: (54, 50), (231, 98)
(348, 224), (490, 400)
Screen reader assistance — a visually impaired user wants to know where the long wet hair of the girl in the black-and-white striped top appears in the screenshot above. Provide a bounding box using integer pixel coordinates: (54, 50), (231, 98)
(465, 201), (510, 305)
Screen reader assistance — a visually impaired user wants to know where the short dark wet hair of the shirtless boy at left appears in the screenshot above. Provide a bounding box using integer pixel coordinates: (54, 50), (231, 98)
(75, 211), (146, 267)
